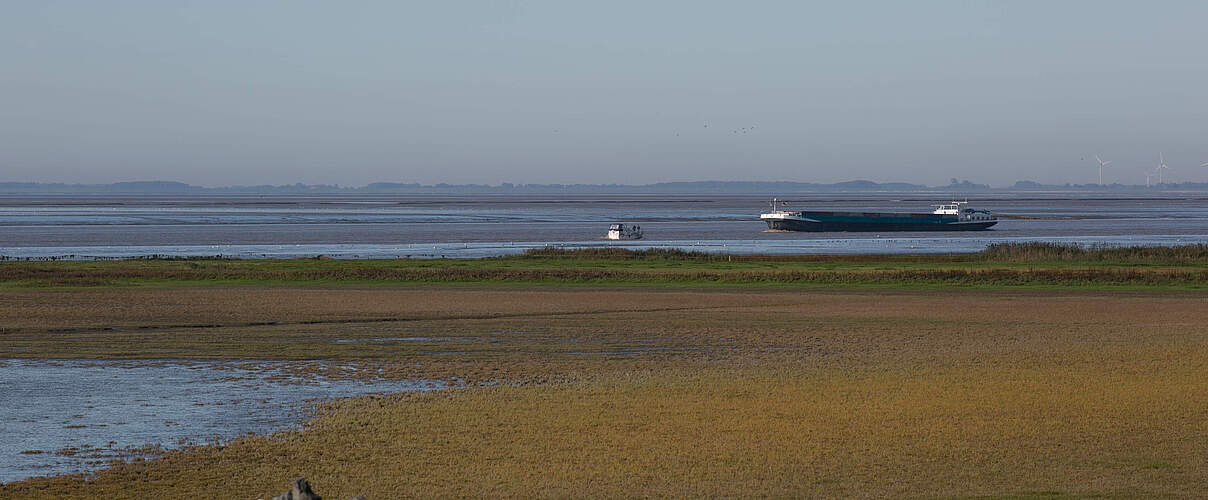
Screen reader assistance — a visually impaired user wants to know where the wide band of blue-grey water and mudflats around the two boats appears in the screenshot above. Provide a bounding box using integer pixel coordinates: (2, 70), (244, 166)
(0, 192), (1208, 258)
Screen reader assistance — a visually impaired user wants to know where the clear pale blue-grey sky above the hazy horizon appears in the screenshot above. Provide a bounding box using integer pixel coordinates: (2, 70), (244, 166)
(0, 0), (1208, 186)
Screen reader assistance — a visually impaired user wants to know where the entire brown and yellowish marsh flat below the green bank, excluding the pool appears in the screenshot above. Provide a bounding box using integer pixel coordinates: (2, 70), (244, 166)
(0, 250), (1208, 499)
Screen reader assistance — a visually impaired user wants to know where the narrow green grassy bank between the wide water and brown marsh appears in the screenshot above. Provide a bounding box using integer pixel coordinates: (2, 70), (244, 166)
(7, 243), (1208, 290)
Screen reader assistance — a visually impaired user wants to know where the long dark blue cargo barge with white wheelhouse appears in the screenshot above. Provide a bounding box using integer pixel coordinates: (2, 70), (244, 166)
(760, 199), (998, 232)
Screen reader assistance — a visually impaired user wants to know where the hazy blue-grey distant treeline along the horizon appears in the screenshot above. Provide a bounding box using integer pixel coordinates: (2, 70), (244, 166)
(0, 179), (1208, 196)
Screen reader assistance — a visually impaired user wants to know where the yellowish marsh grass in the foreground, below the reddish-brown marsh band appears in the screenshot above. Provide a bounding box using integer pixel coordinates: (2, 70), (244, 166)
(7, 345), (1208, 498)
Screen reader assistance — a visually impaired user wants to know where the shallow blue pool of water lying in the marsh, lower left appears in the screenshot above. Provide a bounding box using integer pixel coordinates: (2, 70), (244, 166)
(0, 360), (434, 482)
